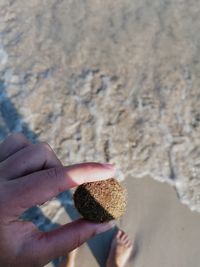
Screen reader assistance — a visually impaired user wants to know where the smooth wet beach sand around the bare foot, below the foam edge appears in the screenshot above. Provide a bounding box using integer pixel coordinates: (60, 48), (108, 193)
(45, 178), (200, 267)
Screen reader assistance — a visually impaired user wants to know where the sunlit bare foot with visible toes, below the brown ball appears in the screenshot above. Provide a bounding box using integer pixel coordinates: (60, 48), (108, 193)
(106, 230), (133, 267)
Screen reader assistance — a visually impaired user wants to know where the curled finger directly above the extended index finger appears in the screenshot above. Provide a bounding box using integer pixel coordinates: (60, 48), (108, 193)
(0, 143), (61, 180)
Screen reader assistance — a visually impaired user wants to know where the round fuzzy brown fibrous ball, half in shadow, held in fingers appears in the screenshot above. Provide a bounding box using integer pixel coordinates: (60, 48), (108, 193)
(74, 178), (127, 222)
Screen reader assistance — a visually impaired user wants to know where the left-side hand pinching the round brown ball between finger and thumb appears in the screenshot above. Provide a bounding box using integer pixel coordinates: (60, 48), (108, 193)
(0, 134), (114, 267)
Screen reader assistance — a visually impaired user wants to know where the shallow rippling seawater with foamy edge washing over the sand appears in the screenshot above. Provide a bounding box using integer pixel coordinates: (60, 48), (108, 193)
(0, 0), (200, 215)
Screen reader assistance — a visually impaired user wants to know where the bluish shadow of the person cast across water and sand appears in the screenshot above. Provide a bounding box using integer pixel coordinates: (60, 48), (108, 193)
(0, 85), (116, 267)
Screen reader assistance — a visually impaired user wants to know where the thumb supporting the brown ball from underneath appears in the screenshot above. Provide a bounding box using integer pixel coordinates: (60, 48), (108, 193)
(37, 219), (115, 264)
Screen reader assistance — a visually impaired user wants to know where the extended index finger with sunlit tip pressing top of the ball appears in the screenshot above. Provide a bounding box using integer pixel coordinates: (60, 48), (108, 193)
(4, 163), (115, 215)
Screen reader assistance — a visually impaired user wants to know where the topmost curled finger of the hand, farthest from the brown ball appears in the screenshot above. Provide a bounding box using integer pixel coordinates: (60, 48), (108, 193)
(0, 133), (31, 162)
